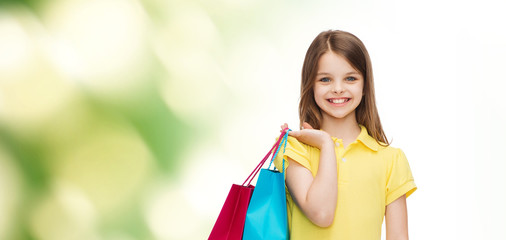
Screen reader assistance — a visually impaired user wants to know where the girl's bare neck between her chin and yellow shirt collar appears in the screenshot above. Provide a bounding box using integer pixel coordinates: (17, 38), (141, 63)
(321, 114), (361, 145)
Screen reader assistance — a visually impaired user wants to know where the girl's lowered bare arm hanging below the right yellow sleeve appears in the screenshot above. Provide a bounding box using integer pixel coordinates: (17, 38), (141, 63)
(386, 194), (409, 240)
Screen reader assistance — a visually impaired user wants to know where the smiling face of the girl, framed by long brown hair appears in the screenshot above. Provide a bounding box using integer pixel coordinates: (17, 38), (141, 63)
(314, 51), (364, 121)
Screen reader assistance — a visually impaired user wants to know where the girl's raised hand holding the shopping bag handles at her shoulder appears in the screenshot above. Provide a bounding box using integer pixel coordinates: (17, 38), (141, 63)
(281, 122), (334, 149)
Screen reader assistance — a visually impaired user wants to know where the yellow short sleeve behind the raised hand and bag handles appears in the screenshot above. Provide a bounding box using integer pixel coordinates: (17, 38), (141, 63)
(273, 136), (311, 171)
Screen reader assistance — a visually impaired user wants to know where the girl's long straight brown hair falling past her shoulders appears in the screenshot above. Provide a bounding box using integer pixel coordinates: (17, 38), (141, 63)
(299, 30), (389, 145)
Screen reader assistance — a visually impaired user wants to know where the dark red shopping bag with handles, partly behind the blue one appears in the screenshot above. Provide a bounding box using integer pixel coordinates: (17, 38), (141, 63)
(209, 130), (286, 240)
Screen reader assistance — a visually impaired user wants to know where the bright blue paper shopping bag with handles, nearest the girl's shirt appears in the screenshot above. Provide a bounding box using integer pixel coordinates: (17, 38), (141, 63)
(243, 131), (289, 240)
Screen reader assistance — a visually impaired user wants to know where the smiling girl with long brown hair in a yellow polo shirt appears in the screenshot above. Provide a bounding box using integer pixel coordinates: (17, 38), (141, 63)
(275, 31), (416, 240)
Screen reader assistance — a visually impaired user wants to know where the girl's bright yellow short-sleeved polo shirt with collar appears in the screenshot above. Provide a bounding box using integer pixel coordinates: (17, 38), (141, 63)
(274, 126), (416, 240)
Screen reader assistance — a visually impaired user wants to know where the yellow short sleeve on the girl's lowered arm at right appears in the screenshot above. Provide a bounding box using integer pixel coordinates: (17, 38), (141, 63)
(386, 149), (417, 205)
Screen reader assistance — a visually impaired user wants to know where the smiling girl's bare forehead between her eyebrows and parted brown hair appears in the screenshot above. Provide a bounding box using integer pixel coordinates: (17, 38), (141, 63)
(318, 51), (358, 74)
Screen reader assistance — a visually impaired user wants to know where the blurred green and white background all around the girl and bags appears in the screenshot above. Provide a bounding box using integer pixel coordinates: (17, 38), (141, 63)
(0, 0), (506, 240)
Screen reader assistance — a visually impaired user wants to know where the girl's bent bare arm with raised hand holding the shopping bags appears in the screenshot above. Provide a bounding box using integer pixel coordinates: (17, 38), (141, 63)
(286, 123), (337, 227)
